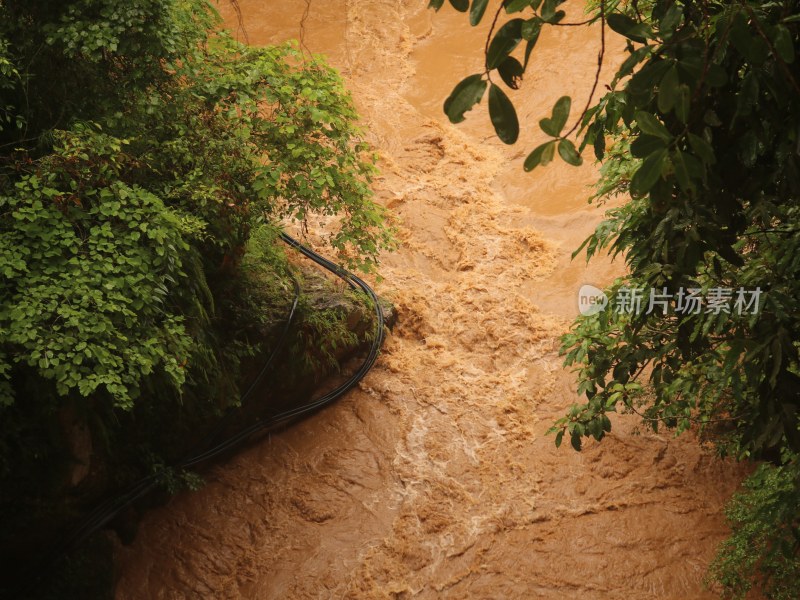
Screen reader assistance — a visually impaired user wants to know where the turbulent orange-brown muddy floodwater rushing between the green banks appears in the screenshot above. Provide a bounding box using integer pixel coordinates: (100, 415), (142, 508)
(117, 0), (741, 600)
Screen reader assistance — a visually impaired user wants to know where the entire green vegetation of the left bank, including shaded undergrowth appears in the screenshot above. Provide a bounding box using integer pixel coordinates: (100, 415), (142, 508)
(0, 0), (393, 570)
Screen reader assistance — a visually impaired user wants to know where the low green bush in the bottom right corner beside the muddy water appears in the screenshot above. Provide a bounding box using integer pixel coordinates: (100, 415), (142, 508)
(709, 462), (800, 600)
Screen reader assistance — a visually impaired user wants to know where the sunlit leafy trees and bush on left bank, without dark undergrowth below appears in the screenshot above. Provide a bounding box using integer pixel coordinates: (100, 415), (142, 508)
(0, 0), (391, 408)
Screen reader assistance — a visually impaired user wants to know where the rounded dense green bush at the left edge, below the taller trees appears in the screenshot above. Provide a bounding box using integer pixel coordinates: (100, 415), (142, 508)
(0, 129), (202, 408)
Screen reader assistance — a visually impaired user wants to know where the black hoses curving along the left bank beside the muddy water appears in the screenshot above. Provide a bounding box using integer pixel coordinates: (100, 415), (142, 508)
(8, 233), (384, 597)
